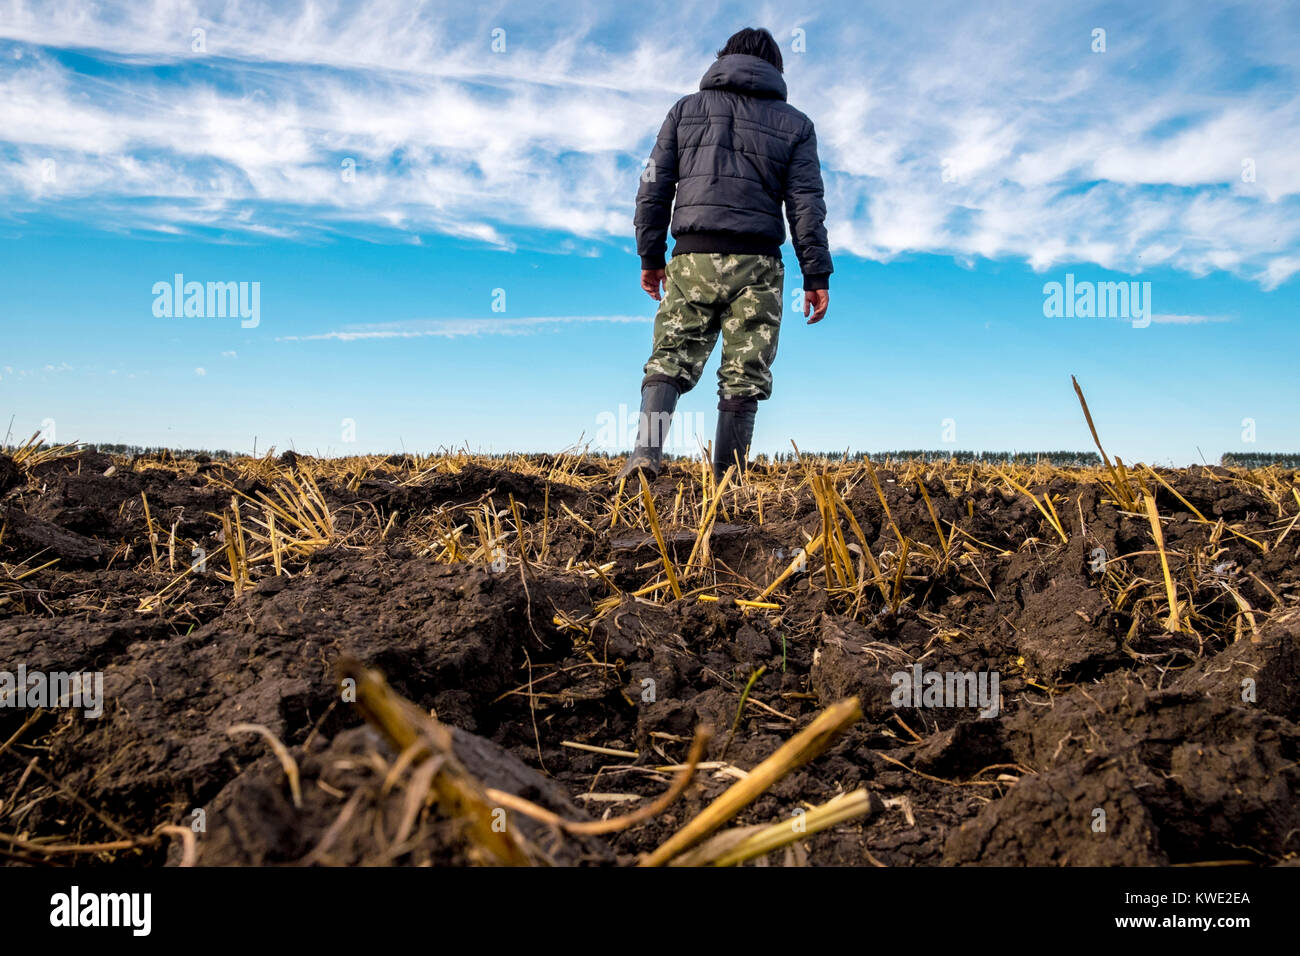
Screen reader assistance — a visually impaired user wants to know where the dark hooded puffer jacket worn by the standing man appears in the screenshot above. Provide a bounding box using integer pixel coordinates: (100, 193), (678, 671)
(636, 53), (833, 290)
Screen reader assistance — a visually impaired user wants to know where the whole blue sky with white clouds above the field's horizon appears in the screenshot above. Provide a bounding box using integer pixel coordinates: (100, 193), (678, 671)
(0, 0), (1300, 464)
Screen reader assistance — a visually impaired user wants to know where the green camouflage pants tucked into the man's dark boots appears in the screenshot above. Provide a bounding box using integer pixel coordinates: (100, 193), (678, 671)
(644, 252), (785, 399)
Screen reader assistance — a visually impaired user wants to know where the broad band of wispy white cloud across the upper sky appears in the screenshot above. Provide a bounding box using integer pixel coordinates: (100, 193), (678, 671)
(0, 0), (1300, 289)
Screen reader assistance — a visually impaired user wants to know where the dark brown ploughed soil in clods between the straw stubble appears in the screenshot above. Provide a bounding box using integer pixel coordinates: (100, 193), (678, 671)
(0, 453), (1300, 866)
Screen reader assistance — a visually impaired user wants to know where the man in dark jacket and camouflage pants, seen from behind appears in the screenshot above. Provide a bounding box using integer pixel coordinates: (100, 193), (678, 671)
(619, 29), (832, 479)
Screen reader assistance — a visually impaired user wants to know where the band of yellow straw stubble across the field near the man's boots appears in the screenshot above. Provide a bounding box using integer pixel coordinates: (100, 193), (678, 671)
(0, 429), (1300, 660)
